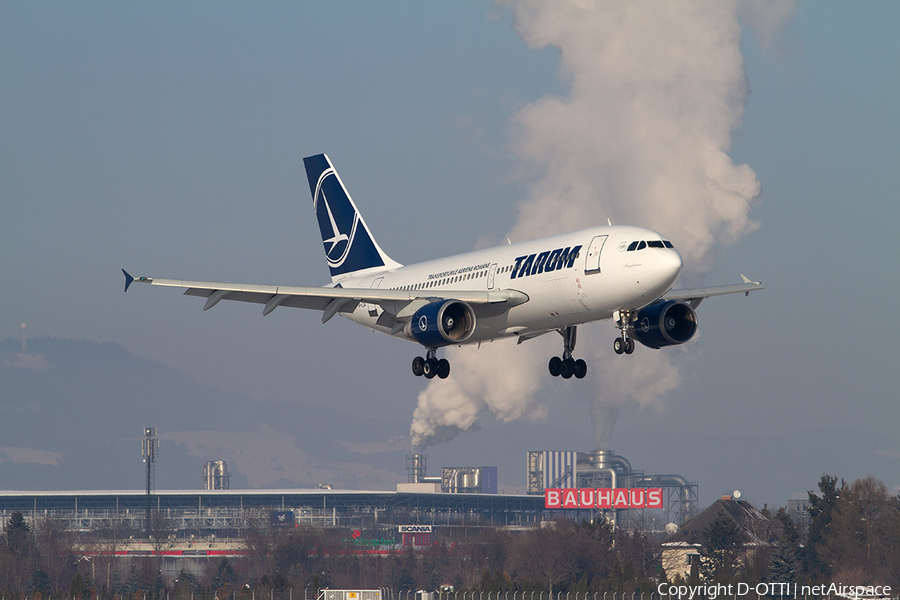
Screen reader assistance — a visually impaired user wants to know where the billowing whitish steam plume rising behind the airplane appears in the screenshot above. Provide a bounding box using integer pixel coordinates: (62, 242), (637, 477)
(411, 0), (793, 447)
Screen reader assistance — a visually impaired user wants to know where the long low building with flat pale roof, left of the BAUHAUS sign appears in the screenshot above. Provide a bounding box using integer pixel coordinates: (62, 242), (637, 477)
(0, 489), (540, 537)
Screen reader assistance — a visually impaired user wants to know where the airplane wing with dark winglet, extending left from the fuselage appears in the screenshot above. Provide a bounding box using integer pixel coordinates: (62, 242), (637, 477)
(122, 269), (528, 323)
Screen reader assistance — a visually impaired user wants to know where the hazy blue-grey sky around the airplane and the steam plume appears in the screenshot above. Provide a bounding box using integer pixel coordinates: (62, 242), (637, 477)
(0, 2), (900, 503)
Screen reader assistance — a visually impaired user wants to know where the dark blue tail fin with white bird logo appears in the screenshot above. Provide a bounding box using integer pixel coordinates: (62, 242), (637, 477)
(303, 154), (400, 281)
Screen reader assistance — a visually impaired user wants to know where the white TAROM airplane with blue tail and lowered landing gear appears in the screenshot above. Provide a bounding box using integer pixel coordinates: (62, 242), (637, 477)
(122, 154), (764, 379)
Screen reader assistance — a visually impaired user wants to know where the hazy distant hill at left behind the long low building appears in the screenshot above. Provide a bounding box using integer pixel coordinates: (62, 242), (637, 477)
(0, 337), (409, 490)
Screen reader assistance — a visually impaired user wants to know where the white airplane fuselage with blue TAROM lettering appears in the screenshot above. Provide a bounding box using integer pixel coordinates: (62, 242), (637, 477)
(337, 226), (682, 344)
